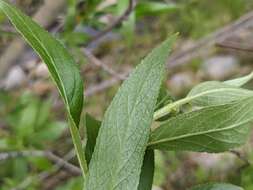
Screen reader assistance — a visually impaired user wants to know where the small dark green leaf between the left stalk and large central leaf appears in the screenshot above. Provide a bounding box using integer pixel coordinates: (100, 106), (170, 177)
(85, 114), (101, 164)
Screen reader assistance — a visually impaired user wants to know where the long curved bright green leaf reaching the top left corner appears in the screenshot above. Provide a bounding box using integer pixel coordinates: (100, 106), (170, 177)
(0, 0), (83, 126)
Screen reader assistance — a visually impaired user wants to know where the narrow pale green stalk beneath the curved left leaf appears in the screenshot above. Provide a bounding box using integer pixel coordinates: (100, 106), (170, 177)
(70, 118), (88, 179)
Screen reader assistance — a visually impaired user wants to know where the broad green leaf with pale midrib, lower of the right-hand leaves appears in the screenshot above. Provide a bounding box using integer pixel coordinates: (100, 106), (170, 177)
(149, 97), (253, 152)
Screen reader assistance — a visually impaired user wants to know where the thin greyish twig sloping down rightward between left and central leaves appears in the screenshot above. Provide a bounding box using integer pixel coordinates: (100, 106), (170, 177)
(82, 48), (126, 80)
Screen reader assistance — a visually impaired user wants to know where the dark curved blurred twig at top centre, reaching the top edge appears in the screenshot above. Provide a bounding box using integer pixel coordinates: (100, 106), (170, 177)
(89, 0), (137, 43)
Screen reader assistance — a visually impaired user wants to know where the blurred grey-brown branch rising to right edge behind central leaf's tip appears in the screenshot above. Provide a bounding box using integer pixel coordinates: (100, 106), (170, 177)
(85, 11), (253, 96)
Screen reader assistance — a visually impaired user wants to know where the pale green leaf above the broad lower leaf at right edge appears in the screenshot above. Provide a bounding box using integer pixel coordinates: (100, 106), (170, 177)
(187, 81), (253, 107)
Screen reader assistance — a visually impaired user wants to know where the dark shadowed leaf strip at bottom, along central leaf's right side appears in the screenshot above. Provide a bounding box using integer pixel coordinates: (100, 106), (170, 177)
(138, 150), (155, 190)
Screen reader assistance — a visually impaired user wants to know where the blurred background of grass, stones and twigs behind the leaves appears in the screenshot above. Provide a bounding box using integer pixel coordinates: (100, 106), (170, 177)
(0, 0), (253, 190)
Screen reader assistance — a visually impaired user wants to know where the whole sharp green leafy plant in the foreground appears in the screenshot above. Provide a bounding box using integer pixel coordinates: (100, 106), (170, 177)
(0, 0), (253, 190)
